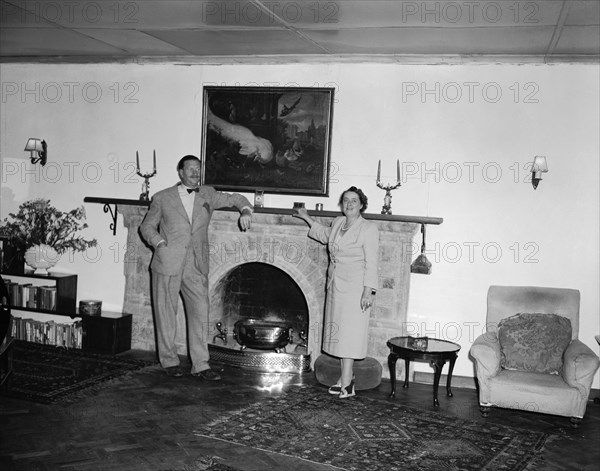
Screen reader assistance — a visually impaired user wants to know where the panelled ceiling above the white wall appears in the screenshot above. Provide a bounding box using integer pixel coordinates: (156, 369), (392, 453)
(0, 0), (600, 63)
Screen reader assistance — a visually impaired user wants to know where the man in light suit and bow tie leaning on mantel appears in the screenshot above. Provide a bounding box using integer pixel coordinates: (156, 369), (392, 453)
(140, 155), (252, 381)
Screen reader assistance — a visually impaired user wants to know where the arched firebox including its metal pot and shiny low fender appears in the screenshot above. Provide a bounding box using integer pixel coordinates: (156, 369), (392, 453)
(209, 262), (311, 373)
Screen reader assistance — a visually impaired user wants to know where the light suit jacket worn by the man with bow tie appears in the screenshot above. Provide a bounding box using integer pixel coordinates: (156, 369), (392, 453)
(140, 184), (252, 276)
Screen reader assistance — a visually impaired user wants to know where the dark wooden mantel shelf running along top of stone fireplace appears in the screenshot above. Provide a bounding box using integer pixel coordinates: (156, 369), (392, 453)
(83, 196), (444, 235)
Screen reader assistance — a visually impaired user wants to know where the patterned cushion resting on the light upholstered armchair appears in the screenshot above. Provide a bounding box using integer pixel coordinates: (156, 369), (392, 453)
(498, 313), (572, 374)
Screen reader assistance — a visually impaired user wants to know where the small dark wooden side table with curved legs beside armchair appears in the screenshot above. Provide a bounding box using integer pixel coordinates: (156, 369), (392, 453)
(387, 337), (461, 407)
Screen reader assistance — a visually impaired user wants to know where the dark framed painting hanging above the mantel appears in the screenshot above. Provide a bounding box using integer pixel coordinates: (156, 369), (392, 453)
(201, 86), (334, 196)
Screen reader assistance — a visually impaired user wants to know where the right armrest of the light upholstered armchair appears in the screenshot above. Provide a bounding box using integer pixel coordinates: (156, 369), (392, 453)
(562, 339), (600, 398)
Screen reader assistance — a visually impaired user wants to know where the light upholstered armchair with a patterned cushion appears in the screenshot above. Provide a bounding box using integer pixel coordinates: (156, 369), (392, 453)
(470, 286), (600, 427)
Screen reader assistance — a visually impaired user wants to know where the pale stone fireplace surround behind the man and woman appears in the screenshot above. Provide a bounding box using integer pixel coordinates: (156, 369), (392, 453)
(118, 205), (441, 374)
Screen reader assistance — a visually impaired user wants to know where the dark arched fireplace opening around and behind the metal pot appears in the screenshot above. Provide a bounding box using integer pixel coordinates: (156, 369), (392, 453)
(221, 262), (309, 344)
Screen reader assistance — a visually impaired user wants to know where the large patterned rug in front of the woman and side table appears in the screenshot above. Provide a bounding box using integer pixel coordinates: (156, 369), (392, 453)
(195, 387), (549, 471)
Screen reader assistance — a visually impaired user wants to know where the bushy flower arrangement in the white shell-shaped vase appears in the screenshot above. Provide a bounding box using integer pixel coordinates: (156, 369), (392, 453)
(0, 198), (97, 254)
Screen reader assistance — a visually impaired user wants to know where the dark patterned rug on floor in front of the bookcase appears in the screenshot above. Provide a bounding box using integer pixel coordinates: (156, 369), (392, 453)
(2, 340), (151, 404)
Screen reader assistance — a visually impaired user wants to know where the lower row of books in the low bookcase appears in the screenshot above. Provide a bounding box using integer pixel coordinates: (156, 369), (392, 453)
(10, 317), (83, 348)
